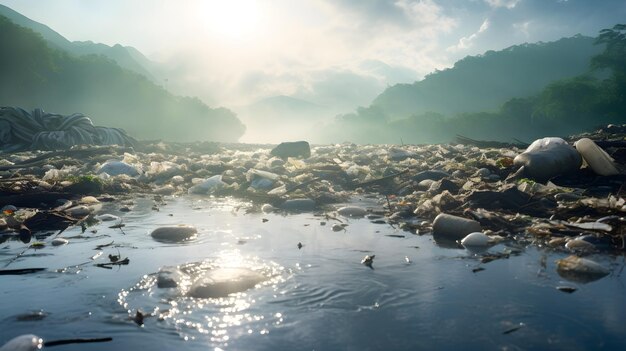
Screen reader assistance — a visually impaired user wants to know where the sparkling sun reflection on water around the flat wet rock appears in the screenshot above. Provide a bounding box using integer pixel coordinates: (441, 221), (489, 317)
(118, 250), (291, 347)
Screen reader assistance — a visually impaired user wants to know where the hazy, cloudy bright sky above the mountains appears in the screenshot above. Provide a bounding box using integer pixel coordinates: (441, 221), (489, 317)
(0, 0), (626, 110)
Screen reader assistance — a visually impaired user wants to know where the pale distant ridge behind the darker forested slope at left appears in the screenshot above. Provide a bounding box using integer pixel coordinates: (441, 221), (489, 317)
(0, 5), (155, 81)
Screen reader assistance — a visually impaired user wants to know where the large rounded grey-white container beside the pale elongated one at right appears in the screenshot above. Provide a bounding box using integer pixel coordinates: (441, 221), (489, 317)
(513, 138), (582, 182)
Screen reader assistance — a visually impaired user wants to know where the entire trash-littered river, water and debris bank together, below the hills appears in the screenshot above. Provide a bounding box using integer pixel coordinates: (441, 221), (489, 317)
(0, 130), (626, 351)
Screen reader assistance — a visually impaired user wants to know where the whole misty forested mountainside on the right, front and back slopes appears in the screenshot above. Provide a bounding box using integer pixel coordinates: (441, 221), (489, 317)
(320, 24), (626, 143)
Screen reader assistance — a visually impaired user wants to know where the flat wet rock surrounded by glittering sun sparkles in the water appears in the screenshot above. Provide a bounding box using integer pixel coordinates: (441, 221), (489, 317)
(187, 268), (267, 298)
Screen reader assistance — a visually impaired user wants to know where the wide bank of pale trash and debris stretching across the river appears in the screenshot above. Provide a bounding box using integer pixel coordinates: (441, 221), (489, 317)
(0, 126), (626, 252)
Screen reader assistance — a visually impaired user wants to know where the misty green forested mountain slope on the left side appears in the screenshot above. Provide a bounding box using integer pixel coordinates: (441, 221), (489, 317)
(0, 16), (245, 141)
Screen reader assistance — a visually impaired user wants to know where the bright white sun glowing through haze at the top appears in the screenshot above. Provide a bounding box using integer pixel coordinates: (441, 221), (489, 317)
(195, 0), (261, 40)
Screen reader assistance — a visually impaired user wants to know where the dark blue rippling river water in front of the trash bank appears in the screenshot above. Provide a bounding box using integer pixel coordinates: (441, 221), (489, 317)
(0, 197), (626, 350)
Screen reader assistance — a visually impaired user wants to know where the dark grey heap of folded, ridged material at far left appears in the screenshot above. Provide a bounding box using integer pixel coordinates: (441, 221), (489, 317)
(0, 107), (135, 152)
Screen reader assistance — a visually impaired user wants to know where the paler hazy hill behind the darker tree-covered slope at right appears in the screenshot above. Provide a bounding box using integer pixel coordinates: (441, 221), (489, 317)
(372, 35), (603, 119)
